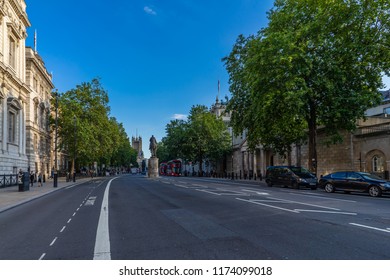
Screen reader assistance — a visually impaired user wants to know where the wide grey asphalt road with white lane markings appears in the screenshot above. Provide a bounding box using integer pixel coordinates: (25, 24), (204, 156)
(0, 175), (390, 260)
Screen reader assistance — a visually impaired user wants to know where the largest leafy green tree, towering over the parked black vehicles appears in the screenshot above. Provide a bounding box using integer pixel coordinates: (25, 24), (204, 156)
(223, 0), (390, 171)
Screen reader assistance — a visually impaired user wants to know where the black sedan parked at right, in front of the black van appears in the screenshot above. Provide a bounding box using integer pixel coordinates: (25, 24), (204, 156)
(319, 171), (390, 197)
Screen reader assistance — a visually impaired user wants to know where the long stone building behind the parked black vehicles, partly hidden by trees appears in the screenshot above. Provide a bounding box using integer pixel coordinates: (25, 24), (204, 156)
(211, 90), (390, 179)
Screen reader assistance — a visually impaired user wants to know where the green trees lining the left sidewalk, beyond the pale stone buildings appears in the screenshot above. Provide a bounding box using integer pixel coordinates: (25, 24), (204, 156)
(52, 79), (136, 171)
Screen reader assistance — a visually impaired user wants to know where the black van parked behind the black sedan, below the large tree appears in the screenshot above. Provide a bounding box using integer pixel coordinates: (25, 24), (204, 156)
(265, 166), (317, 190)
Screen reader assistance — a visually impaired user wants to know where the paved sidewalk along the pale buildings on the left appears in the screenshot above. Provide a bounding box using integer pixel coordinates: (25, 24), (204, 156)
(0, 177), (91, 213)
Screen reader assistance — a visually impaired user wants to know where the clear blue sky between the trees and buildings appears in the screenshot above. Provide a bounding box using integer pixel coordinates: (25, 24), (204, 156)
(26, 0), (390, 156)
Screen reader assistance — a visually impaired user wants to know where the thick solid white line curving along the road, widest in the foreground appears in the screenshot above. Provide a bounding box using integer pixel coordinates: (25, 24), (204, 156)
(93, 177), (118, 260)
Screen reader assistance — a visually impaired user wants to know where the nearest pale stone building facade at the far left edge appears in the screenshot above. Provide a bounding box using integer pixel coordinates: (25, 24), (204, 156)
(0, 0), (31, 174)
